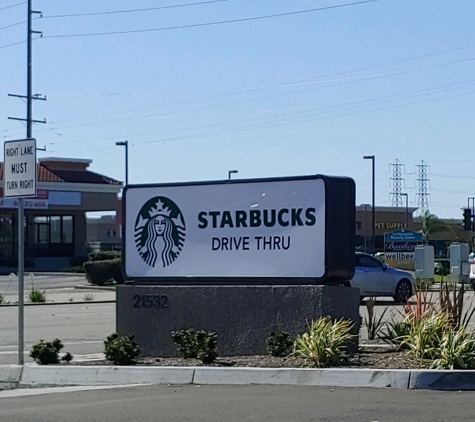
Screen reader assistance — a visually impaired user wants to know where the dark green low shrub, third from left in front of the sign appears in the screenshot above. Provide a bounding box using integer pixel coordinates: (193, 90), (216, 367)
(172, 328), (218, 363)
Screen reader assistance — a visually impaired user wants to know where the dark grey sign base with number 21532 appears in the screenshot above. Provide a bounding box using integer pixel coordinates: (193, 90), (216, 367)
(116, 285), (360, 357)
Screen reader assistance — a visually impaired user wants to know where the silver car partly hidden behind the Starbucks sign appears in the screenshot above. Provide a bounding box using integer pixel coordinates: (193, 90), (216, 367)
(342, 252), (416, 303)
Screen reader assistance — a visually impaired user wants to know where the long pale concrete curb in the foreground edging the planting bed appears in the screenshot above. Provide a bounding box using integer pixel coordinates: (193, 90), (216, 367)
(5, 364), (475, 391)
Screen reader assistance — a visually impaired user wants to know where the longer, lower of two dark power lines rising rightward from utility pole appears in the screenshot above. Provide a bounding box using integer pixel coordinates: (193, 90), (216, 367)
(44, 0), (380, 38)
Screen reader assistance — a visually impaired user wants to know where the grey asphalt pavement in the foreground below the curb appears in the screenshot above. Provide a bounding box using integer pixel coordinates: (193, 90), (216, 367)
(0, 385), (475, 422)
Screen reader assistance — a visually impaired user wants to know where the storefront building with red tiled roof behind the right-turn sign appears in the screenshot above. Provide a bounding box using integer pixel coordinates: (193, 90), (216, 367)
(0, 158), (122, 271)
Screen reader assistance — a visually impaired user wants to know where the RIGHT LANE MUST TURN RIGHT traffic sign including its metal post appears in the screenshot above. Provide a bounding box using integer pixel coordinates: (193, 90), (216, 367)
(3, 139), (37, 365)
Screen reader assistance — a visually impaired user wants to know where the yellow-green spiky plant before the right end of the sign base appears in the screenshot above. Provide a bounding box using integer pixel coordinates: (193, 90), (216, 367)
(294, 317), (353, 367)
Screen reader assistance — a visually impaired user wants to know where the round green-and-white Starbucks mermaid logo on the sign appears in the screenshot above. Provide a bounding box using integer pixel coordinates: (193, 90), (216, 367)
(135, 196), (186, 268)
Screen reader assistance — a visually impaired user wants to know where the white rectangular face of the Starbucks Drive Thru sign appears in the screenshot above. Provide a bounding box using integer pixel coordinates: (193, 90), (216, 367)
(124, 179), (325, 278)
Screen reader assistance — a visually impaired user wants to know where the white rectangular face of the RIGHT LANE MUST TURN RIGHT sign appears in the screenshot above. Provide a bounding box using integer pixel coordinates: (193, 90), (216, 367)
(3, 139), (36, 198)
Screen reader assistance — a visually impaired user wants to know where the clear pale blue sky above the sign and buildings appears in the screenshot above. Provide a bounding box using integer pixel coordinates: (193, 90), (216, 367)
(0, 0), (475, 218)
